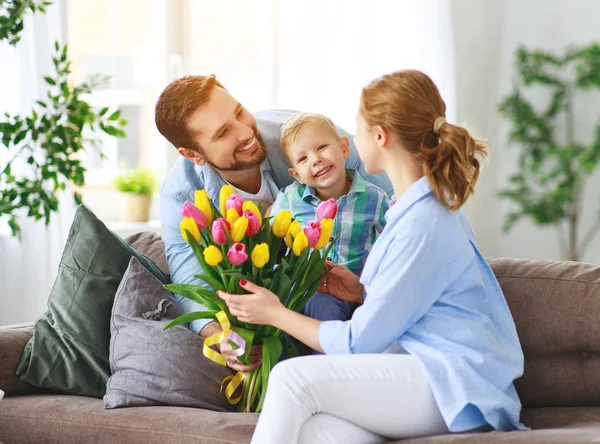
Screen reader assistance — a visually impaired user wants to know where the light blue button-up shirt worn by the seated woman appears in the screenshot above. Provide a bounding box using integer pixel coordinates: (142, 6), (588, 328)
(319, 178), (524, 432)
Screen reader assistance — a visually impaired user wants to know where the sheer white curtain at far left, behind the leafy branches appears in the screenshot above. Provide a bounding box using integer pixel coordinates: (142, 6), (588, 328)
(0, 0), (75, 325)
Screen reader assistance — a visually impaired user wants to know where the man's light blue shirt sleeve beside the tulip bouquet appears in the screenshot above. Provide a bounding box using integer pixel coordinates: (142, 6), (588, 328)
(160, 191), (212, 334)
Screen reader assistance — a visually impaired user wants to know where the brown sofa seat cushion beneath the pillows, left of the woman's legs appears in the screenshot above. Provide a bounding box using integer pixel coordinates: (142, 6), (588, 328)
(0, 395), (258, 444)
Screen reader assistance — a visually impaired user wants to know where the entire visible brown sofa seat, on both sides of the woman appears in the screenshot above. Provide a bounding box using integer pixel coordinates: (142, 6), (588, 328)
(0, 395), (600, 444)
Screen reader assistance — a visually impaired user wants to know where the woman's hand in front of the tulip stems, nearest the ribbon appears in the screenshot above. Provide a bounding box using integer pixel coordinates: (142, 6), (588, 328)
(217, 280), (285, 325)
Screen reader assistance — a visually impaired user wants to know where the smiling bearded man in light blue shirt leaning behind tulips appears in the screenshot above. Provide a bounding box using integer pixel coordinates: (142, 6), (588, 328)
(155, 76), (392, 371)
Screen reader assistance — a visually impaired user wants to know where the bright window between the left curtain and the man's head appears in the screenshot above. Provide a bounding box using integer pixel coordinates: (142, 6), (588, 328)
(67, 0), (168, 187)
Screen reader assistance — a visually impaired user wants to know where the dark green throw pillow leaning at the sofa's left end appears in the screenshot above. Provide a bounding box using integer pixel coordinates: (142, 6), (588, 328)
(16, 205), (168, 398)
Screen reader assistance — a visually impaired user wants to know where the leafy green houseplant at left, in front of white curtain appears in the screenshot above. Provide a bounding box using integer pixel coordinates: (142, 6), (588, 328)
(0, 0), (127, 235)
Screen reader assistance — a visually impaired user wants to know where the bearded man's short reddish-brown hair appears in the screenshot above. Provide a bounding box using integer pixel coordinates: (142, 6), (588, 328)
(154, 75), (225, 150)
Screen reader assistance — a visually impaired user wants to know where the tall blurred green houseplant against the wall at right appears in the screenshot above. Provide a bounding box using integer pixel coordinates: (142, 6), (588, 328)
(499, 43), (600, 261)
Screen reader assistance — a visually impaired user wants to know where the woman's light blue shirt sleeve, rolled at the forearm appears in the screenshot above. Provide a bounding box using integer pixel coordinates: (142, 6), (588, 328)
(318, 234), (468, 354)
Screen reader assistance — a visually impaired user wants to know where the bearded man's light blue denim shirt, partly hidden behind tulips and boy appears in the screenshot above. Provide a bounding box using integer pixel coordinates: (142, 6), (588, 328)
(160, 110), (392, 333)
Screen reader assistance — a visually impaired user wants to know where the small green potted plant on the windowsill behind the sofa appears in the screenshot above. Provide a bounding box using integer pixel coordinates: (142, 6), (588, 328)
(114, 166), (158, 222)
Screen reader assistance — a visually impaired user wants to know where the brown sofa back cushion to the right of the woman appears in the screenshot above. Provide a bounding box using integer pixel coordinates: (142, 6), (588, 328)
(489, 259), (600, 410)
